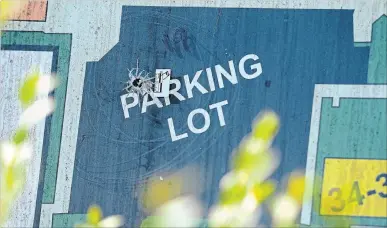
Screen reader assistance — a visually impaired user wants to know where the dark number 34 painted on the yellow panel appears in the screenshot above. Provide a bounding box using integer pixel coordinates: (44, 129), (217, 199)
(328, 181), (365, 212)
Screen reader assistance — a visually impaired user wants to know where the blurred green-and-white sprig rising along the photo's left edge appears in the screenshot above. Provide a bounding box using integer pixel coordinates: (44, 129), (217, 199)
(0, 71), (57, 226)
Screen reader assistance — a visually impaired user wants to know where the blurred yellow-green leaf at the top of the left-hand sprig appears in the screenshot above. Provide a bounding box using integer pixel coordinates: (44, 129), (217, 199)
(19, 70), (40, 106)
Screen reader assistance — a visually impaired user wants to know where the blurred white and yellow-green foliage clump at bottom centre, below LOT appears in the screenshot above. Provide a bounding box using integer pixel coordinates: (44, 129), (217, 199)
(141, 112), (305, 228)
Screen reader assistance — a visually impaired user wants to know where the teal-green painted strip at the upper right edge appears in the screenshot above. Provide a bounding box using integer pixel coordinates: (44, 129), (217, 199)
(367, 15), (387, 84)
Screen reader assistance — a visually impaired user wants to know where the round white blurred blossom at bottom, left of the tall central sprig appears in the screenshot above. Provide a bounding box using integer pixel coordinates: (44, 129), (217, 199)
(155, 196), (202, 227)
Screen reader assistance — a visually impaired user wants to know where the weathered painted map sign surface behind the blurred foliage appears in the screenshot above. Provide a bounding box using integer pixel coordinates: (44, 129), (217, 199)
(0, 0), (387, 227)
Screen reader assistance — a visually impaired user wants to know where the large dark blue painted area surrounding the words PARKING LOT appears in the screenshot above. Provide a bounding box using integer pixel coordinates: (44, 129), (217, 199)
(69, 7), (369, 227)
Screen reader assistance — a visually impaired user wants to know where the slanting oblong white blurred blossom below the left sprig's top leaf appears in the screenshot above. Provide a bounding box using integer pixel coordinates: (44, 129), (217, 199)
(19, 97), (55, 127)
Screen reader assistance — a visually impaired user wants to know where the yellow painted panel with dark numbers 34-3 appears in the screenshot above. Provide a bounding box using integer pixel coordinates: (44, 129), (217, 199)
(320, 158), (387, 217)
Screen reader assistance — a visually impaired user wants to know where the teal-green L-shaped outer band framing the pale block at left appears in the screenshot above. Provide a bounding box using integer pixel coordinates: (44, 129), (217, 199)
(1, 31), (72, 204)
